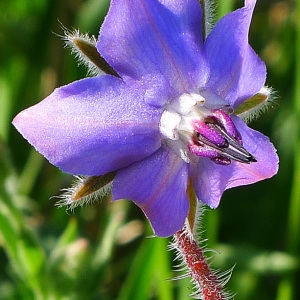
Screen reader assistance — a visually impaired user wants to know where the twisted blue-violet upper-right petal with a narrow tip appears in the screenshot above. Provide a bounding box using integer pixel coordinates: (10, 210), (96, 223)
(205, 1), (266, 108)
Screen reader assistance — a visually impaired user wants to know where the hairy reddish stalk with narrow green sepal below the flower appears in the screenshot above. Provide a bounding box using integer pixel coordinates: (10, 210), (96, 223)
(170, 181), (232, 300)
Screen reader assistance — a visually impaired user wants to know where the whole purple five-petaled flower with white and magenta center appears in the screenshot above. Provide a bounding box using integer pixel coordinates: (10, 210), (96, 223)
(13, 0), (278, 236)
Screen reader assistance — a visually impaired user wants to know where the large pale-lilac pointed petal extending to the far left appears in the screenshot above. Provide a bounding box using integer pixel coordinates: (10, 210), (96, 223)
(13, 75), (162, 175)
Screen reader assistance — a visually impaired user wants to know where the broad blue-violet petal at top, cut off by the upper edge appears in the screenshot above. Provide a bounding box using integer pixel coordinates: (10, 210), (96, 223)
(97, 0), (207, 91)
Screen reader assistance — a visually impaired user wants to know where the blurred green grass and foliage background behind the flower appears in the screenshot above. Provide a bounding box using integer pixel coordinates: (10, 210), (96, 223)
(0, 0), (300, 300)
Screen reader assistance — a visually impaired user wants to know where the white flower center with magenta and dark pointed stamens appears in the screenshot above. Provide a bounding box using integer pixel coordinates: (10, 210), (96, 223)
(159, 93), (256, 165)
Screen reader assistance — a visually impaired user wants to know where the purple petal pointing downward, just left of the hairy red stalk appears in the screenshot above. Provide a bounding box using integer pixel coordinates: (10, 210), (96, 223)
(112, 148), (189, 236)
